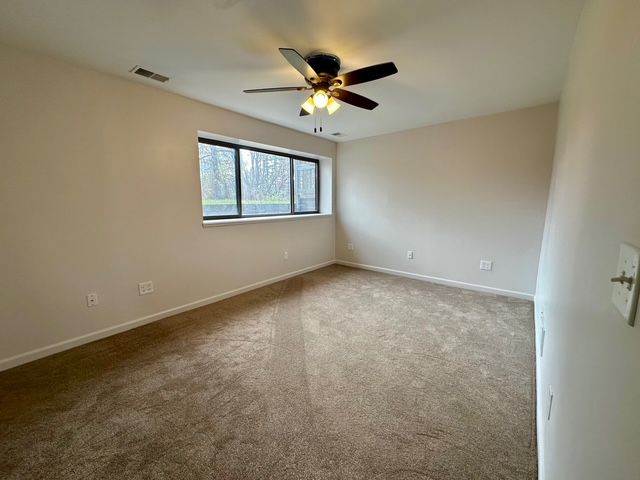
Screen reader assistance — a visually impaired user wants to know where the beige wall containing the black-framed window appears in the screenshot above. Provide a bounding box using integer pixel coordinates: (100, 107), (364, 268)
(0, 46), (336, 368)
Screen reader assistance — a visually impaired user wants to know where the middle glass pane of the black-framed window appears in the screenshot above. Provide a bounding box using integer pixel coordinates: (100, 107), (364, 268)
(240, 150), (291, 215)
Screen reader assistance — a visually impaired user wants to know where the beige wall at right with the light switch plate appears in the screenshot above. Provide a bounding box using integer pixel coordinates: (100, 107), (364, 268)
(536, 0), (640, 480)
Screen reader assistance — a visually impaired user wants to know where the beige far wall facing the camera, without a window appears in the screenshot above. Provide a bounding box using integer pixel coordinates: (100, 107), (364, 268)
(336, 104), (557, 294)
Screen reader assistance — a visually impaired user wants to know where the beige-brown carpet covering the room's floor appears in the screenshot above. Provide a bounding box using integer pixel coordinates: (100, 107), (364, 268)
(0, 266), (536, 480)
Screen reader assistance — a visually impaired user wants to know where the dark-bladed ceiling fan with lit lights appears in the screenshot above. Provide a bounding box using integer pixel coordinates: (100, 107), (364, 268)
(244, 48), (398, 117)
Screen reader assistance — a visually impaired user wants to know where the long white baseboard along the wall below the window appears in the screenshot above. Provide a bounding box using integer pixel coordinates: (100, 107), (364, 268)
(0, 260), (335, 371)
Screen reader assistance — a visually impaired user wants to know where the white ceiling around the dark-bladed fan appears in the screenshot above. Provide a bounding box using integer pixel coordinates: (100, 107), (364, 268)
(0, 0), (584, 140)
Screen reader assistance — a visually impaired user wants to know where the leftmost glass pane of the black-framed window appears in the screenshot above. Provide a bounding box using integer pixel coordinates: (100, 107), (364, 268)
(198, 143), (239, 217)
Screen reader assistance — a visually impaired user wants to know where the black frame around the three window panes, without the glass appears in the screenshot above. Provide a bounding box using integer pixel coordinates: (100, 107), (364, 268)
(198, 137), (320, 220)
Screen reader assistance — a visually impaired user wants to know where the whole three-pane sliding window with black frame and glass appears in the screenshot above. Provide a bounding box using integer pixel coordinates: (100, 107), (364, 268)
(198, 138), (320, 220)
